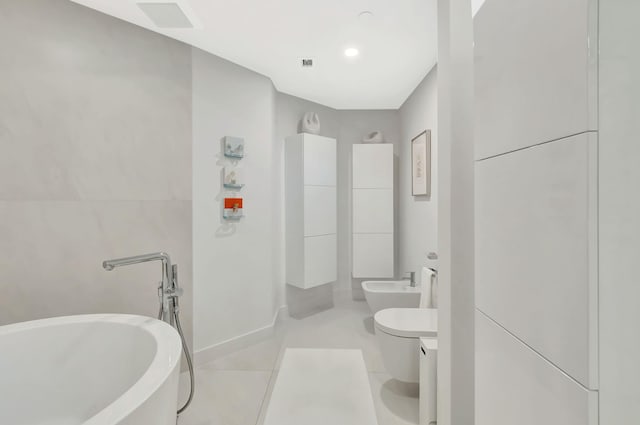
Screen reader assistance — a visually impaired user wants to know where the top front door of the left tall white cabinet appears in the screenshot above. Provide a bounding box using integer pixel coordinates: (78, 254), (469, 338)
(304, 134), (336, 186)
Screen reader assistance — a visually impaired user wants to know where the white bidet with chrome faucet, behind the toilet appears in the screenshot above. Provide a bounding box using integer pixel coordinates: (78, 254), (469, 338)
(362, 280), (421, 314)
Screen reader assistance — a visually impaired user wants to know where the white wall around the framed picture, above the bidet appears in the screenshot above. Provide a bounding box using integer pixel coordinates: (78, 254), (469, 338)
(396, 67), (440, 275)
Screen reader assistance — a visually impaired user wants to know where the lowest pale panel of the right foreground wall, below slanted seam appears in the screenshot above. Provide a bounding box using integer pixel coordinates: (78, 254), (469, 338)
(475, 313), (598, 425)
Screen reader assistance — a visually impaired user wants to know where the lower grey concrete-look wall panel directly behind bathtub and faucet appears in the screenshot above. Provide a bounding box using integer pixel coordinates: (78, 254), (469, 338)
(0, 201), (193, 346)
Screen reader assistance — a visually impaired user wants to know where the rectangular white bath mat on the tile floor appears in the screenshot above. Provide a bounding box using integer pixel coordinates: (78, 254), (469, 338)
(264, 348), (378, 425)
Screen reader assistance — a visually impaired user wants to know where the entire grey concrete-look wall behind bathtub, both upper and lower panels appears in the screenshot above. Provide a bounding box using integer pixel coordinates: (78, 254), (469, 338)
(0, 0), (192, 339)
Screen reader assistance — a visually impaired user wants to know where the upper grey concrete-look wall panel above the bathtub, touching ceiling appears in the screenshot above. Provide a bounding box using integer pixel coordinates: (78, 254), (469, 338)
(0, 0), (191, 200)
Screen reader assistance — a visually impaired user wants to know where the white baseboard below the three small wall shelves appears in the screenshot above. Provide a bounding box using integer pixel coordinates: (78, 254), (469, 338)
(193, 306), (289, 367)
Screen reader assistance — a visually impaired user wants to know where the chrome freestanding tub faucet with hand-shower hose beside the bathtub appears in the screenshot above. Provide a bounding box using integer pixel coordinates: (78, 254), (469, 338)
(102, 252), (195, 414)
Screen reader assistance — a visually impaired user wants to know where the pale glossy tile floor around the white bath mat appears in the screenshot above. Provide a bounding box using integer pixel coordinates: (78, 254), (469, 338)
(178, 293), (418, 425)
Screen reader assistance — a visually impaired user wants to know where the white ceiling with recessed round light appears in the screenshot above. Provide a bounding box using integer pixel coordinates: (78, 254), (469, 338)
(72, 0), (437, 109)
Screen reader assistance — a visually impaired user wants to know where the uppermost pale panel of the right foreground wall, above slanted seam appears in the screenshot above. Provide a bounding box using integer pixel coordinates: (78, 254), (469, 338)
(474, 0), (598, 159)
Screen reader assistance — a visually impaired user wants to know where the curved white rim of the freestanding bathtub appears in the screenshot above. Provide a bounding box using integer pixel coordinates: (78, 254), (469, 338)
(0, 314), (182, 425)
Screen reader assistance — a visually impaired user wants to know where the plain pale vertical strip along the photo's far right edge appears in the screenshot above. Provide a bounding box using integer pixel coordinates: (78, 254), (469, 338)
(599, 1), (640, 425)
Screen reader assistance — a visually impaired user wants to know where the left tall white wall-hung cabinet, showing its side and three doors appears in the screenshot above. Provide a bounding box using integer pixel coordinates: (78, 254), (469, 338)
(285, 133), (338, 289)
